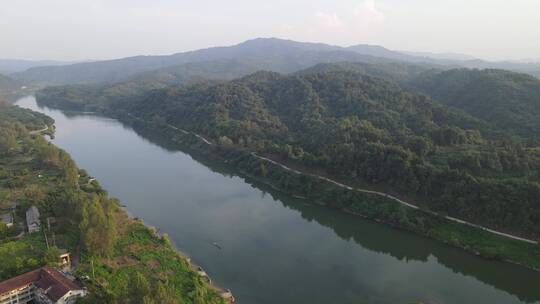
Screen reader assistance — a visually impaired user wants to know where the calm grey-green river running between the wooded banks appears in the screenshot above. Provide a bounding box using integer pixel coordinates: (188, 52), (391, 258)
(17, 96), (540, 304)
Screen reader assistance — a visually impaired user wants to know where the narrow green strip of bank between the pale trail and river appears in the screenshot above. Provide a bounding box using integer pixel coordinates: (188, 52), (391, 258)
(117, 116), (540, 271)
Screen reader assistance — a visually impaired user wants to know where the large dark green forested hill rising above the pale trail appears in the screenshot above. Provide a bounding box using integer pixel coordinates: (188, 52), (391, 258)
(38, 70), (540, 239)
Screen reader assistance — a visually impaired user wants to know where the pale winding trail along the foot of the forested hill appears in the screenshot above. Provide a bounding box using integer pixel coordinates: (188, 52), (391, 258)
(128, 113), (538, 244)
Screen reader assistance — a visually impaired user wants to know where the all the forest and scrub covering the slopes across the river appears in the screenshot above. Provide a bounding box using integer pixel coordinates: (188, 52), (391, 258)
(37, 64), (540, 269)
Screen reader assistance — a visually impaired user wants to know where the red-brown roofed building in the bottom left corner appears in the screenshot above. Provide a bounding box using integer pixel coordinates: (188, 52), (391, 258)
(0, 266), (86, 304)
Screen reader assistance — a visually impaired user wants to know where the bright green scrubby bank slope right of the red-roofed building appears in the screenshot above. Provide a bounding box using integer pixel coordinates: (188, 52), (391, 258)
(77, 212), (234, 303)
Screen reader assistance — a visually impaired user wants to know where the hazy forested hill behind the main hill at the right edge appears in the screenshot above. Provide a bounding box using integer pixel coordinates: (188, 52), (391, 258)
(413, 69), (540, 141)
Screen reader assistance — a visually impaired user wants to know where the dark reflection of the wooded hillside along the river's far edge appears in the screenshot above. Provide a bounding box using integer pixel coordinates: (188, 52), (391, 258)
(75, 117), (540, 302)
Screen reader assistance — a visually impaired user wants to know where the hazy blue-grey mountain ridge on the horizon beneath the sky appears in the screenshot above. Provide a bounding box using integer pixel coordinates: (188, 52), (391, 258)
(11, 38), (540, 85)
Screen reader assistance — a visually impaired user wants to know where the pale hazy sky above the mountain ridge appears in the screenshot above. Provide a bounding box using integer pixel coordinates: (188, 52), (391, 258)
(0, 0), (540, 60)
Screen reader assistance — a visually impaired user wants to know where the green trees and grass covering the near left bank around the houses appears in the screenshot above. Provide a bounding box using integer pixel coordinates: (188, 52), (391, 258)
(0, 102), (223, 303)
